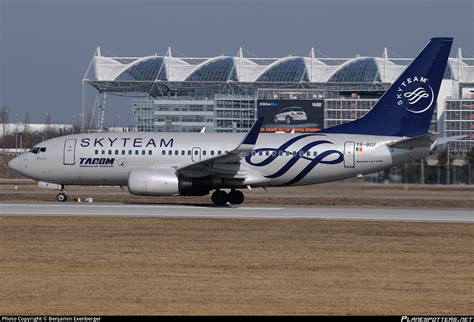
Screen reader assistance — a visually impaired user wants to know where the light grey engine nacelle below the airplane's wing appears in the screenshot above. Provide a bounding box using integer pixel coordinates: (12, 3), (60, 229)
(128, 170), (179, 196)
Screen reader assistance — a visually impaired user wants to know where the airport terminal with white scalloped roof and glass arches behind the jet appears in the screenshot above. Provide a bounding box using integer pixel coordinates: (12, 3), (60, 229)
(84, 48), (474, 152)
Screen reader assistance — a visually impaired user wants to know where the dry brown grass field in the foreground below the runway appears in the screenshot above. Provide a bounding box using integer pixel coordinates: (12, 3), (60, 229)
(0, 217), (474, 315)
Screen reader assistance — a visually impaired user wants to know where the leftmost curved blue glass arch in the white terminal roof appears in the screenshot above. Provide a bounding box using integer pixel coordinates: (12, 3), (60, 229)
(115, 57), (167, 82)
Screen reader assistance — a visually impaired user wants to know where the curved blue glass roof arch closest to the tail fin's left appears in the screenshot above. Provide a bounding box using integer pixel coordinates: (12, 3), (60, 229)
(328, 58), (381, 83)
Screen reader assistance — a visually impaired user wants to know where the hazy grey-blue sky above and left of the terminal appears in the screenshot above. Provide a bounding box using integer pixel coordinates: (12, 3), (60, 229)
(0, 0), (474, 124)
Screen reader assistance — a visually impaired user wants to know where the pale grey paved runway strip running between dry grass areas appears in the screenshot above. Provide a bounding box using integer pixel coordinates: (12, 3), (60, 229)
(0, 203), (474, 223)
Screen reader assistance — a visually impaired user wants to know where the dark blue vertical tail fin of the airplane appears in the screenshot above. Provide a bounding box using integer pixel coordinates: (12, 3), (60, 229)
(321, 38), (453, 137)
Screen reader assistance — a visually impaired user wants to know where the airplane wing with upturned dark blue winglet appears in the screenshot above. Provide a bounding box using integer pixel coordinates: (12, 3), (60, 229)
(176, 117), (263, 177)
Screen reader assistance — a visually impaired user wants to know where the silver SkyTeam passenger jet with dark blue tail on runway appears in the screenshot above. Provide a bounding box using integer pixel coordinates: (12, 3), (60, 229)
(9, 38), (453, 205)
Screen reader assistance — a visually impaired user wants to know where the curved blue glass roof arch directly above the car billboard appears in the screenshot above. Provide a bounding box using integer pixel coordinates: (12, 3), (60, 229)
(257, 57), (309, 83)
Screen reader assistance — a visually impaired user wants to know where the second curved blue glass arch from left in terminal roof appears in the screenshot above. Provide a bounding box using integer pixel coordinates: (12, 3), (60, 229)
(186, 57), (237, 82)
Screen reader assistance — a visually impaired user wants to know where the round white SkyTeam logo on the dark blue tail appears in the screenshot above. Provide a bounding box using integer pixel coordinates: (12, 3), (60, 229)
(396, 76), (434, 114)
